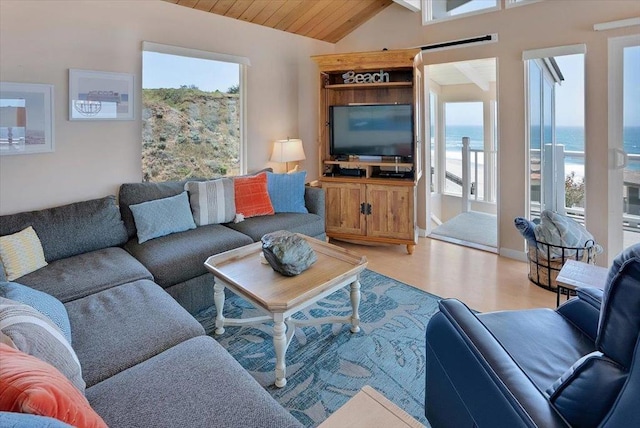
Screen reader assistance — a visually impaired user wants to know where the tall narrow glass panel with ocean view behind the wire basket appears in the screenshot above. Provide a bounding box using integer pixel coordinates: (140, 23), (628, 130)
(523, 45), (585, 221)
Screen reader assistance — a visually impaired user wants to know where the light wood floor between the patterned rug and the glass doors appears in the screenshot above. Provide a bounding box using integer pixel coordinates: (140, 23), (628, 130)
(331, 238), (556, 312)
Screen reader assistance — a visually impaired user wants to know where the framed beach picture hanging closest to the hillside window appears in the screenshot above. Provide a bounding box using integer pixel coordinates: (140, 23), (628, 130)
(69, 69), (134, 120)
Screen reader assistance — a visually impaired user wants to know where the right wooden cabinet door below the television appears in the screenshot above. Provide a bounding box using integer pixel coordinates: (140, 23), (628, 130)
(367, 184), (415, 239)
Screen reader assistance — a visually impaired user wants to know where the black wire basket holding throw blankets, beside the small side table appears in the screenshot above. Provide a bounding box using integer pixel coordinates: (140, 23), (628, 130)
(528, 239), (596, 291)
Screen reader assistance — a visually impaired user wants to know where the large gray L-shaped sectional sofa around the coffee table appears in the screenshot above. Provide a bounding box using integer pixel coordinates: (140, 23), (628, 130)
(0, 182), (324, 428)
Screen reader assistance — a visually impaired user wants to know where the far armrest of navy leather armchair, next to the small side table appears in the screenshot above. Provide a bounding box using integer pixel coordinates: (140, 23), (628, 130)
(557, 287), (603, 342)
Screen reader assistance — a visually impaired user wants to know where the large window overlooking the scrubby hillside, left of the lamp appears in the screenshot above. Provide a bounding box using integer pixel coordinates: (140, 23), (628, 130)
(142, 42), (248, 181)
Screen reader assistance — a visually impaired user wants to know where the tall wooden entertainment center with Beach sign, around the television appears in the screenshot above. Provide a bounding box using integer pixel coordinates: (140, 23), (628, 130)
(312, 49), (422, 254)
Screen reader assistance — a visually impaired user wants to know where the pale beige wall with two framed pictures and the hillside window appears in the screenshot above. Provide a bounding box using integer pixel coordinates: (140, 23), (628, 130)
(0, 0), (334, 214)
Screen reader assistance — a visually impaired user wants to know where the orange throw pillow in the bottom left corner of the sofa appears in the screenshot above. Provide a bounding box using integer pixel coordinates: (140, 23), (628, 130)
(0, 343), (107, 428)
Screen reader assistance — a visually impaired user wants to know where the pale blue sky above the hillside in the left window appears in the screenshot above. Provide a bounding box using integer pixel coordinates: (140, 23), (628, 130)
(142, 52), (240, 92)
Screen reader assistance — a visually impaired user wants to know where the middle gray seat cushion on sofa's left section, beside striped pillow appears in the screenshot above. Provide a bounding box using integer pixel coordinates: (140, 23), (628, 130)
(65, 280), (204, 386)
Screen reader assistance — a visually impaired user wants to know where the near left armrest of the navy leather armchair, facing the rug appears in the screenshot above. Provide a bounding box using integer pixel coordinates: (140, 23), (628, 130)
(425, 299), (567, 428)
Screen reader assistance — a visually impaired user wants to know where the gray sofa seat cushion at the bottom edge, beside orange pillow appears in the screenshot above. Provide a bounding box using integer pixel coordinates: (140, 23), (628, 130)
(87, 336), (302, 428)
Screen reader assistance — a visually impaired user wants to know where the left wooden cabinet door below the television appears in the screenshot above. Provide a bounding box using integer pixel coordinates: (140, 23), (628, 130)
(322, 183), (367, 235)
